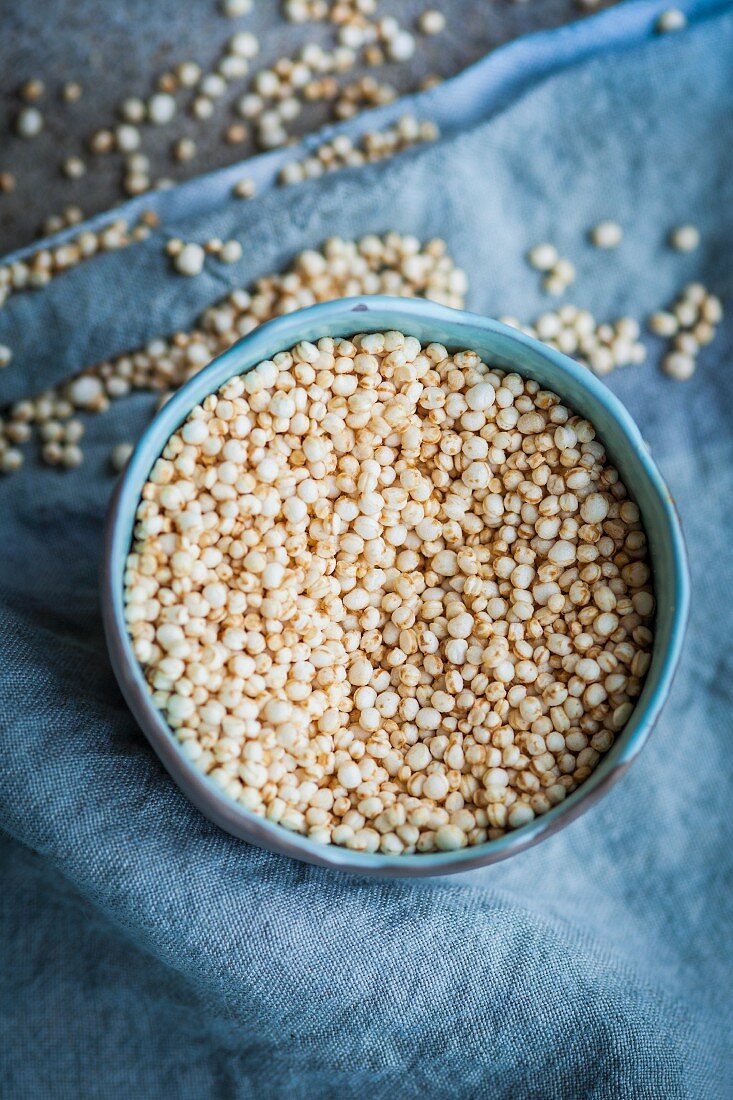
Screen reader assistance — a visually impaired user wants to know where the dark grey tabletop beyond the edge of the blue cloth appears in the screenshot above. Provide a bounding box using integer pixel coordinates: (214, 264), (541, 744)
(0, 0), (608, 253)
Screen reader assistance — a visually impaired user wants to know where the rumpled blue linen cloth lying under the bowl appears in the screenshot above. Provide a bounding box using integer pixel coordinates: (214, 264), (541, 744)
(0, 2), (733, 1100)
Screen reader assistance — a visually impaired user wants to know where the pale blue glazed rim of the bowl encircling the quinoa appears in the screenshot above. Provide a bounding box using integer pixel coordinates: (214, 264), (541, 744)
(101, 295), (690, 878)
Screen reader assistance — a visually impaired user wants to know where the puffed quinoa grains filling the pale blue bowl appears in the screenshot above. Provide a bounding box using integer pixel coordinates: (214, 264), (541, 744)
(124, 332), (655, 855)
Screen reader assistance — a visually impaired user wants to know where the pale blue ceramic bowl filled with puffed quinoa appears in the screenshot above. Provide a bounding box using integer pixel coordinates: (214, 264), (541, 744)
(102, 296), (689, 876)
